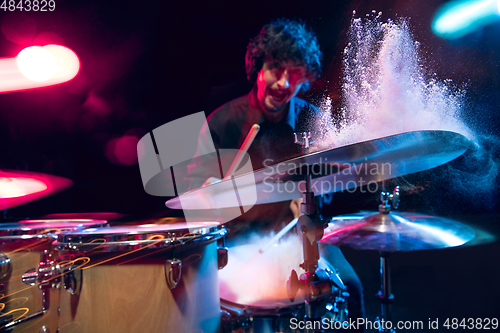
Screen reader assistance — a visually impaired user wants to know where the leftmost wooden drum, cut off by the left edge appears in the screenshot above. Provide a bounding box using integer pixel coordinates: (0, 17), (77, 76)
(0, 219), (106, 332)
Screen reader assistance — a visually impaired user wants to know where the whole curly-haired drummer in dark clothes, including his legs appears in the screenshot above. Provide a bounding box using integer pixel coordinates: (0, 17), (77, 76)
(189, 19), (364, 326)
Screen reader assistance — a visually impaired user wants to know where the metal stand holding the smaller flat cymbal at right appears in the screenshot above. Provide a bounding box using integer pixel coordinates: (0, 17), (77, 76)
(377, 186), (400, 332)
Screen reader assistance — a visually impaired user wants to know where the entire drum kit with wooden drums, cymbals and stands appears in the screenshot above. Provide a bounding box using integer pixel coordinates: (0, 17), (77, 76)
(0, 131), (475, 333)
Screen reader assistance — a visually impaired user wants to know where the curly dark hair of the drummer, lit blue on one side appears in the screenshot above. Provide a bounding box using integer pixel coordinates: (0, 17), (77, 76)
(245, 18), (323, 90)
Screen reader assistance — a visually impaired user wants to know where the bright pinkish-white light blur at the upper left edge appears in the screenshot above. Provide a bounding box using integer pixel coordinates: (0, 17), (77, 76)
(0, 45), (80, 92)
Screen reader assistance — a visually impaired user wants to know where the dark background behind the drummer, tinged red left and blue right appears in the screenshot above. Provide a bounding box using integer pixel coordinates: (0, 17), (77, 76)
(0, 0), (500, 328)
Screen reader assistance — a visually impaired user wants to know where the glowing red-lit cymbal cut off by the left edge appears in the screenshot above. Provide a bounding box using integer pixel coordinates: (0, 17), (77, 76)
(0, 170), (73, 209)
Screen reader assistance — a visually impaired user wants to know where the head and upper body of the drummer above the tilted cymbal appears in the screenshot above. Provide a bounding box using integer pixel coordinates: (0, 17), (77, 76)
(190, 19), (326, 178)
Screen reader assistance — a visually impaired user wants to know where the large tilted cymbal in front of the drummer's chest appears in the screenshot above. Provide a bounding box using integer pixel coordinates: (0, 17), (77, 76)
(166, 131), (470, 211)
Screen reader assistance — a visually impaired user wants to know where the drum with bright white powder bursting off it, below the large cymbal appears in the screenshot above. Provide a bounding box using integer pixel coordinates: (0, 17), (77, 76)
(219, 235), (348, 333)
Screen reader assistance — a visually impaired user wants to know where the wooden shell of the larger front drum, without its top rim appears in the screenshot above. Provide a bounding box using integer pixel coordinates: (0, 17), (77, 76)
(59, 239), (220, 333)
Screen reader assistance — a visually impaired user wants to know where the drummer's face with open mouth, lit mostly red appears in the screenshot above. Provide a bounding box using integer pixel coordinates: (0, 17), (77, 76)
(257, 62), (306, 118)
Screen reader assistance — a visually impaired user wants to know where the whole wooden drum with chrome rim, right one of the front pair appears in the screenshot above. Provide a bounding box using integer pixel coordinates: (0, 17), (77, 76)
(54, 222), (225, 333)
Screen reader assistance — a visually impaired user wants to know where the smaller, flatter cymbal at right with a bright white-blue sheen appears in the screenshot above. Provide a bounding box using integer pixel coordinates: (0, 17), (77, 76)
(321, 212), (476, 252)
